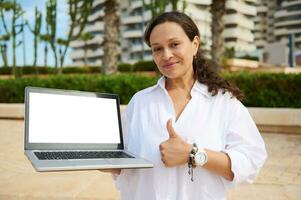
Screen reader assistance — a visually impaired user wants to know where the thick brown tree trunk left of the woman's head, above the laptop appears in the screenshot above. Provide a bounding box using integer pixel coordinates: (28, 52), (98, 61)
(102, 0), (119, 74)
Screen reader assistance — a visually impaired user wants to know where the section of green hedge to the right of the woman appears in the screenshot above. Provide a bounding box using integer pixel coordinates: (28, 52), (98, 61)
(223, 72), (301, 108)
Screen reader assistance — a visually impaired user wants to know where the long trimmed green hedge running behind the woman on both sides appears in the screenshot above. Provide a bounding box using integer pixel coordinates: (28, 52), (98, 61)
(0, 73), (301, 108)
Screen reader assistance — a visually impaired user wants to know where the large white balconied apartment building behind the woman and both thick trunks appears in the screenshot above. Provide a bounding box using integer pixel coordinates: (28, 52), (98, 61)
(70, 0), (256, 66)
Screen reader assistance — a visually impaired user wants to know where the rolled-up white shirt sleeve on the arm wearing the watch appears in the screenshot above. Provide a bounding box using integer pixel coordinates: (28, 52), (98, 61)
(223, 101), (267, 188)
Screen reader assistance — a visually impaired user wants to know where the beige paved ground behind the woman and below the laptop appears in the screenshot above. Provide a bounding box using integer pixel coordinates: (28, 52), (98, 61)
(0, 120), (301, 200)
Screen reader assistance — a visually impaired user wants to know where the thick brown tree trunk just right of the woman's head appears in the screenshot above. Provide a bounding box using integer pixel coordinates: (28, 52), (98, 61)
(211, 0), (226, 71)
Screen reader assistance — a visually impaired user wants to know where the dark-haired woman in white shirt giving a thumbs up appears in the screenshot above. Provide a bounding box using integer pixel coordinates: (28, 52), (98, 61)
(105, 12), (266, 200)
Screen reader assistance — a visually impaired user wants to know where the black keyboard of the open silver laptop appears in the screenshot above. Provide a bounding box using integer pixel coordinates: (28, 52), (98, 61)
(34, 151), (134, 160)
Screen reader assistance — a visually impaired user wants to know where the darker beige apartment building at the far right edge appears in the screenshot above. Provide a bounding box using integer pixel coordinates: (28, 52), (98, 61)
(254, 0), (301, 50)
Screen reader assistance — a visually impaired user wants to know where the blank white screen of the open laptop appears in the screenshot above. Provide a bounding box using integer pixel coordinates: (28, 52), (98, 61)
(28, 93), (120, 144)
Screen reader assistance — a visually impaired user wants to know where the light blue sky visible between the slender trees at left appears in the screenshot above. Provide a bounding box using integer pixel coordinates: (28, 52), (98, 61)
(0, 0), (71, 67)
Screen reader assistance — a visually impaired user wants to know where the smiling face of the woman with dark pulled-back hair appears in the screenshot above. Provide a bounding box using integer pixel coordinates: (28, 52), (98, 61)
(149, 22), (199, 79)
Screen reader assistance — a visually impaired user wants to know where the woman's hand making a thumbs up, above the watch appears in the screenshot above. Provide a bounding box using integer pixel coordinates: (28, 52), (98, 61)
(159, 119), (192, 167)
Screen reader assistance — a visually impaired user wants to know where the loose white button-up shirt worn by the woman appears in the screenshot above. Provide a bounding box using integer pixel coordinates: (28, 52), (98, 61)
(115, 77), (267, 200)
